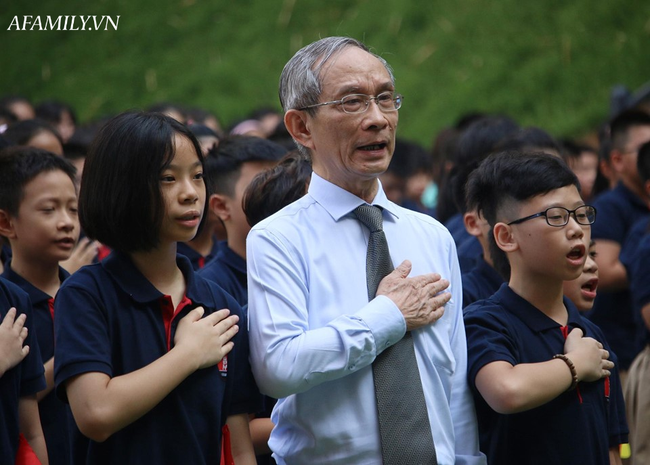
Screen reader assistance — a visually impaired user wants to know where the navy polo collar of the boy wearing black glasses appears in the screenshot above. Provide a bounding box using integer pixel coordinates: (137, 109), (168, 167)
(494, 283), (587, 334)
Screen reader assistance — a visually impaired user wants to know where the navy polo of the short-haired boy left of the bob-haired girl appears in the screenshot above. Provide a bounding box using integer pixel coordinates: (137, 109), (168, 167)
(2, 264), (71, 465)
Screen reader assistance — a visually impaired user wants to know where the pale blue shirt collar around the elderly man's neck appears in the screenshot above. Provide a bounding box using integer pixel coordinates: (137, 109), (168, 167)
(308, 173), (399, 221)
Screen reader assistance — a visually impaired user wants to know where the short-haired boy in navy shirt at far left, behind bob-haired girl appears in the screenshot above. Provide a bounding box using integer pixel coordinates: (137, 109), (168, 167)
(0, 147), (79, 465)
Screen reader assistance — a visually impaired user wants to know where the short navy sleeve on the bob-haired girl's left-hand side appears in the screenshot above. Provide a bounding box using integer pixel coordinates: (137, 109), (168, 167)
(54, 277), (113, 402)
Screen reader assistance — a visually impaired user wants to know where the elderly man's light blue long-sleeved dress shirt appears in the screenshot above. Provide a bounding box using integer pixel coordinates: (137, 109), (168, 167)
(247, 173), (485, 465)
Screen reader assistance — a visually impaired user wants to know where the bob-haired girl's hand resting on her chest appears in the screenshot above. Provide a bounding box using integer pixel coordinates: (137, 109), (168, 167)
(174, 307), (239, 369)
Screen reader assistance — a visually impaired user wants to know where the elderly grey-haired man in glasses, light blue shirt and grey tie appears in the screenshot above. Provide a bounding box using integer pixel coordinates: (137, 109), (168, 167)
(247, 37), (485, 465)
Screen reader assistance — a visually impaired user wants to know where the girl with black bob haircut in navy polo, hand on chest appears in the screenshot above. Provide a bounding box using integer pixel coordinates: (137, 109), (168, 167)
(54, 112), (260, 465)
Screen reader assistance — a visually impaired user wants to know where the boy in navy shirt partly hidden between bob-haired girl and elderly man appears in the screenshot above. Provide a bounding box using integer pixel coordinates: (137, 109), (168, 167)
(200, 136), (287, 305)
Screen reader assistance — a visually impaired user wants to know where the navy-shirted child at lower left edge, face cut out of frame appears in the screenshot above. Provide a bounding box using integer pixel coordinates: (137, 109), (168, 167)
(0, 278), (48, 464)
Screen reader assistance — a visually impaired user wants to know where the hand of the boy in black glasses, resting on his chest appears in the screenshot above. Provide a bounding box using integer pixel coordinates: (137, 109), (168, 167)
(564, 328), (614, 382)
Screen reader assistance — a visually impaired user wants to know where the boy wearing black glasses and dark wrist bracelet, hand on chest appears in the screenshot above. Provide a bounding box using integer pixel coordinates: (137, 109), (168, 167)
(465, 152), (628, 465)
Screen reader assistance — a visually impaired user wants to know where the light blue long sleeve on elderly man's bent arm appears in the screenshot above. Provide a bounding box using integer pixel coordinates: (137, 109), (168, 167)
(247, 229), (406, 398)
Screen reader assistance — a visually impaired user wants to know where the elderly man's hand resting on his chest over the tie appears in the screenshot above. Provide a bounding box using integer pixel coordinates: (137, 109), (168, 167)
(377, 260), (451, 331)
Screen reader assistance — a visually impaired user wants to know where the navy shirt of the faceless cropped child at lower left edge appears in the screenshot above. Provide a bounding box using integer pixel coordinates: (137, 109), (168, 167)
(0, 278), (45, 464)
